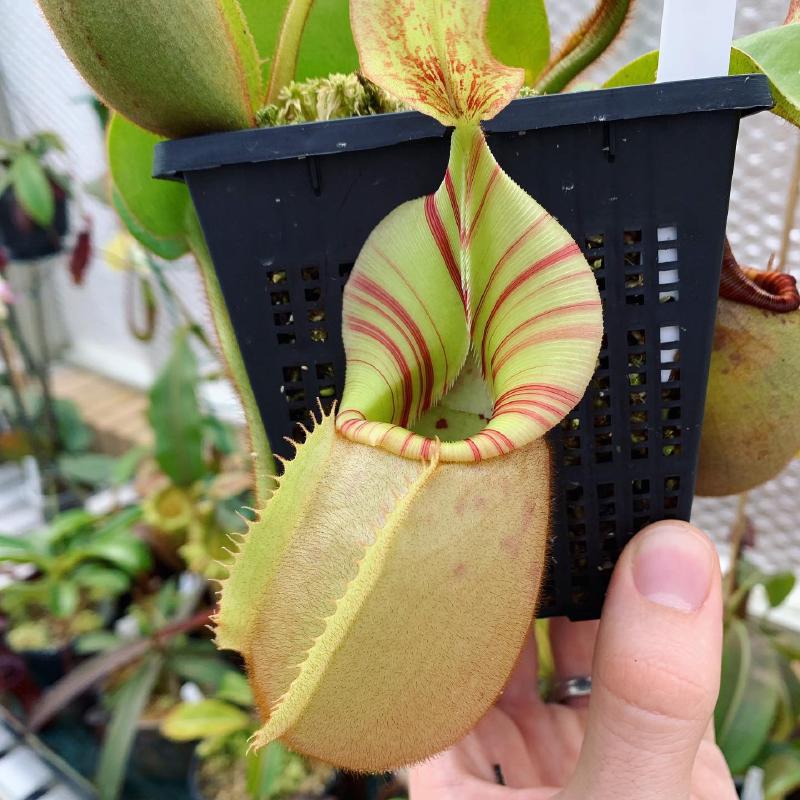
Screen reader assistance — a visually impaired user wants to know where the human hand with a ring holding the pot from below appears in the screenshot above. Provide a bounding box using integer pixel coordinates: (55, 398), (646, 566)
(411, 522), (736, 800)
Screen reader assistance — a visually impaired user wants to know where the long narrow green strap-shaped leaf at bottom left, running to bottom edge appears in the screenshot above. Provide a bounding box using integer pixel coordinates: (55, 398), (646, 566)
(95, 653), (163, 800)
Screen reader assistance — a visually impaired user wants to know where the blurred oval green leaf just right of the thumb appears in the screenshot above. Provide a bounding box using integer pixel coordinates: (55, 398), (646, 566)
(715, 619), (780, 775)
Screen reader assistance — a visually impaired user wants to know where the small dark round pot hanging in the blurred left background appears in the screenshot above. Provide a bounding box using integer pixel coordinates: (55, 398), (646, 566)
(0, 185), (68, 261)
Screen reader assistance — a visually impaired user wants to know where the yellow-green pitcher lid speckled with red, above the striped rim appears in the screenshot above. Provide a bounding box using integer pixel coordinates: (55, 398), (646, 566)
(350, 0), (525, 125)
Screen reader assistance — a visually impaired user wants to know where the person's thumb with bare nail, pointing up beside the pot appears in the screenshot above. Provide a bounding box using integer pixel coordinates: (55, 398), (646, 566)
(564, 521), (722, 800)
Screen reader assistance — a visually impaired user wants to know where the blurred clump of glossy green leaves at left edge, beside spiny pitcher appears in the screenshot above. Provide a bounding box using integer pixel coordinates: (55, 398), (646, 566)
(0, 508), (150, 650)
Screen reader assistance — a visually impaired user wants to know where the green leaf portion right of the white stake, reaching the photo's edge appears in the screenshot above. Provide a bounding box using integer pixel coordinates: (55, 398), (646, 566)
(731, 23), (800, 125)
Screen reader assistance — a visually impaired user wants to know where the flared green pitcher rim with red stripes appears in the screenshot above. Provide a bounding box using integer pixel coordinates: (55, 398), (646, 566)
(337, 124), (602, 462)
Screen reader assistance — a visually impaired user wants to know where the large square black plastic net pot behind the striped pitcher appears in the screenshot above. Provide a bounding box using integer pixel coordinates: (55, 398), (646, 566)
(154, 76), (772, 619)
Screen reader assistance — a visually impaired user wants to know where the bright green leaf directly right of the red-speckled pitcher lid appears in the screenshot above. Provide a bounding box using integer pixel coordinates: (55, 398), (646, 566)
(486, 0), (550, 85)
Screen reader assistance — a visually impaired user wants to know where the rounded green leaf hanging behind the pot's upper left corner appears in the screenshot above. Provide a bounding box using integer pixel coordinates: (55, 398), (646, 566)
(107, 114), (190, 240)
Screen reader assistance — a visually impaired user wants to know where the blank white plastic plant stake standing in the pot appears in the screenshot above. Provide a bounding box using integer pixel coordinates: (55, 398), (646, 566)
(658, 0), (736, 83)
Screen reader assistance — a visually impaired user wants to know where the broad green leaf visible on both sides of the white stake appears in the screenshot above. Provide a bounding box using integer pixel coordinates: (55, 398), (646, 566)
(604, 23), (800, 125)
